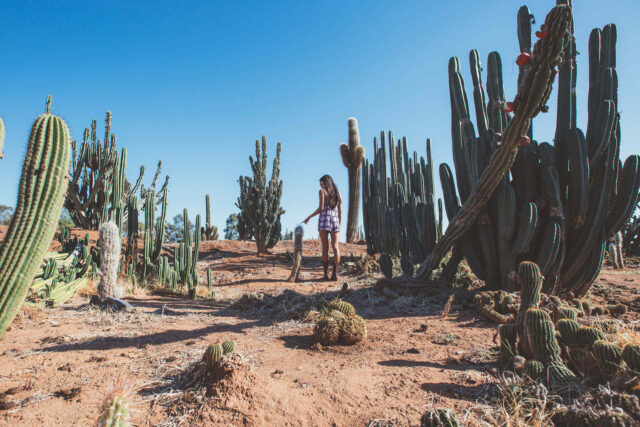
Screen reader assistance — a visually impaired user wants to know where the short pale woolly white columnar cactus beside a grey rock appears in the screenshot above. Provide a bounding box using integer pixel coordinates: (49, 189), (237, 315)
(98, 221), (121, 301)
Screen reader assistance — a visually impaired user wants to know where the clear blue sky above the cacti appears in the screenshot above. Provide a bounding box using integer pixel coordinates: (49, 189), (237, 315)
(0, 0), (640, 241)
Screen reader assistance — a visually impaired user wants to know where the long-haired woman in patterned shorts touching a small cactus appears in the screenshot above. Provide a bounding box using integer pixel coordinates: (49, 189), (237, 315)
(304, 175), (342, 281)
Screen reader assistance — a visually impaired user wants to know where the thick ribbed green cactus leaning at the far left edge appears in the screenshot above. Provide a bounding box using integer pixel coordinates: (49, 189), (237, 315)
(0, 96), (71, 336)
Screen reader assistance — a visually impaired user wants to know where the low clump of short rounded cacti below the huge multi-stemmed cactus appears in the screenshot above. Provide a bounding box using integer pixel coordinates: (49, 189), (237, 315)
(498, 261), (640, 385)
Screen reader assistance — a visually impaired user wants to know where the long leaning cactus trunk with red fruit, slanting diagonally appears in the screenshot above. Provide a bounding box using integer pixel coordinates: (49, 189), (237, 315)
(417, 5), (571, 281)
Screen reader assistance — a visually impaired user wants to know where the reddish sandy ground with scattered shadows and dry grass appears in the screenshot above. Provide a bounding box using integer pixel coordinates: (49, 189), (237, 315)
(0, 226), (640, 426)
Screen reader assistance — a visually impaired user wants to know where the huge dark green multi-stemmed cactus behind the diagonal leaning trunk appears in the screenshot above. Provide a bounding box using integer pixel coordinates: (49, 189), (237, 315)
(424, 1), (640, 295)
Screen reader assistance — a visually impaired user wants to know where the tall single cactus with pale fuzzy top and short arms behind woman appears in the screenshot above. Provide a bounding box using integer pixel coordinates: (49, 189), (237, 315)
(340, 117), (364, 243)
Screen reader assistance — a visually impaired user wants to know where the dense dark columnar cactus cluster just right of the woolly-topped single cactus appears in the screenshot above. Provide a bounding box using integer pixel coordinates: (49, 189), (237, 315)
(362, 132), (442, 277)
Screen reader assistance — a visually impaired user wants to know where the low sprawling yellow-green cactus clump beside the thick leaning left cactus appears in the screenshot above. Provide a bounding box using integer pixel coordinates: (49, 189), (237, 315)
(25, 232), (98, 307)
